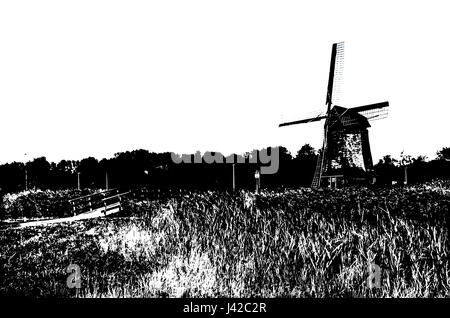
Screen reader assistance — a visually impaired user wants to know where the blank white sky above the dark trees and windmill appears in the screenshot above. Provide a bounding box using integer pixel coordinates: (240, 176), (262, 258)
(0, 0), (450, 163)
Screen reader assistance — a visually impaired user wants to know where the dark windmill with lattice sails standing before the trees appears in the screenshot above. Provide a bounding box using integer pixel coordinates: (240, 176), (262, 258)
(279, 42), (389, 188)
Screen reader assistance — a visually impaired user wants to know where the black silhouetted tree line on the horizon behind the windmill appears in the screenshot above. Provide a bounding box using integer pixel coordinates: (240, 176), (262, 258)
(0, 144), (450, 193)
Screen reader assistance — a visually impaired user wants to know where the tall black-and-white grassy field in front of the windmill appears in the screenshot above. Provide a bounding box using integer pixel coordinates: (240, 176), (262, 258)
(0, 183), (450, 297)
